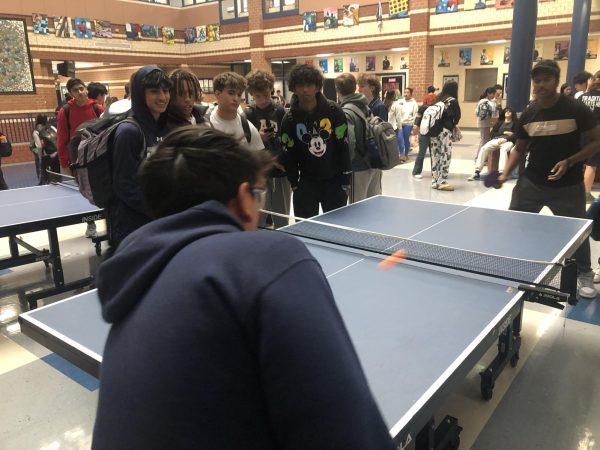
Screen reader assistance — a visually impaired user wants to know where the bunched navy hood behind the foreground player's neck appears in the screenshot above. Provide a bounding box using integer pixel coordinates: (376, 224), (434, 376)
(97, 200), (244, 323)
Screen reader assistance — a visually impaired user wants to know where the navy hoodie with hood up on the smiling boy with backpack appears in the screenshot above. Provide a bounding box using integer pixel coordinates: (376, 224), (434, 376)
(108, 66), (167, 246)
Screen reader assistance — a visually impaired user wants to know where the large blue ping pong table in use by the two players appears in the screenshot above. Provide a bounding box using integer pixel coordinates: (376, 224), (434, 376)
(19, 196), (591, 449)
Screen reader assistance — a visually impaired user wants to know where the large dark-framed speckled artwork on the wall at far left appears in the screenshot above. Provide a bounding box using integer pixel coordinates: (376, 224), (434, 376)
(0, 19), (35, 94)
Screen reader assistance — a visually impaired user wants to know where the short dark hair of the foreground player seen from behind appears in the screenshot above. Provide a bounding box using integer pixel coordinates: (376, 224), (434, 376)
(138, 125), (270, 217)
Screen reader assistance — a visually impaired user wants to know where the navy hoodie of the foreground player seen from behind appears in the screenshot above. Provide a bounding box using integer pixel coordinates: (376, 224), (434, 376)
(92, 201), (393, 450)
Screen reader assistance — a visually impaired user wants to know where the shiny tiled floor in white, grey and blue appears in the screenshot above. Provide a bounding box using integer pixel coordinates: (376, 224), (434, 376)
(0, 131), (600, 450)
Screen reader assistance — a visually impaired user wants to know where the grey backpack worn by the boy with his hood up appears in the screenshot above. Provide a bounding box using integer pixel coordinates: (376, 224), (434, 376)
(71, 113), (146, 208)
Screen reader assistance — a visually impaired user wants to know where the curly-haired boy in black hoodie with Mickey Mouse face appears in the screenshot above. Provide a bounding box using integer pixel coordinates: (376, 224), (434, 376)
(281, 64), (352, 218)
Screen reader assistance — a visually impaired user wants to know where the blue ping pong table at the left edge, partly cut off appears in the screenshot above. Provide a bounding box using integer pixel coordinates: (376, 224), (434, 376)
(0, 183), (104, 308)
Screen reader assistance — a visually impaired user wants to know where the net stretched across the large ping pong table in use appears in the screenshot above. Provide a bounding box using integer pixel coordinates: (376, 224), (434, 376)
(280, 220), (562, 290)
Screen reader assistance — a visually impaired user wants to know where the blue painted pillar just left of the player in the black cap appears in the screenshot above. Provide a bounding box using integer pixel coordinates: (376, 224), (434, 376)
(506, 0), (537, 112)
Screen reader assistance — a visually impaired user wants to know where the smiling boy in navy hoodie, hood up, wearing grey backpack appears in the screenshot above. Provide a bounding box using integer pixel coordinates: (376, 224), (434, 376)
(108, 66), (171, 248)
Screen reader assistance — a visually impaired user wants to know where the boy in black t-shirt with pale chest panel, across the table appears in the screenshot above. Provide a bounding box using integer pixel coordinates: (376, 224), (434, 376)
(495, 60), (600, 299)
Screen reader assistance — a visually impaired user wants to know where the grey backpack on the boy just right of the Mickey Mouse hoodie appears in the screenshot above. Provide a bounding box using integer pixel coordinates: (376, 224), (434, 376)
(344, 103), (400, 170)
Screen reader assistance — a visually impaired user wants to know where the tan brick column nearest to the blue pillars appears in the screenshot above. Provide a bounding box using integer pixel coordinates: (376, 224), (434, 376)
(408, 0), (434, 101)
